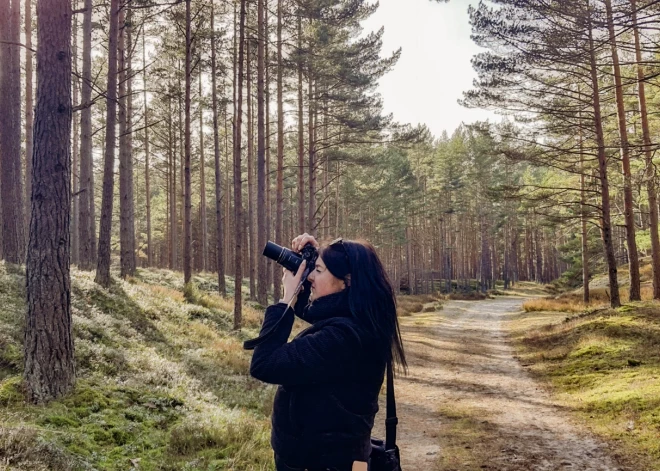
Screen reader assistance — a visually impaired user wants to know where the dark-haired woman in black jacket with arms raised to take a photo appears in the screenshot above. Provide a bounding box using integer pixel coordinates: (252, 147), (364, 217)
(250, 234), (406, 471)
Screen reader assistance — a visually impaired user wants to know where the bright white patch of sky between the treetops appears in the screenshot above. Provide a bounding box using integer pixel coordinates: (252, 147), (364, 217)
(364, 0), (499, 137)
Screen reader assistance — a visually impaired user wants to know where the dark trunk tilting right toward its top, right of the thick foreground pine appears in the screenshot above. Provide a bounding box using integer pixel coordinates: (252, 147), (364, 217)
(95, 0), (120, 288)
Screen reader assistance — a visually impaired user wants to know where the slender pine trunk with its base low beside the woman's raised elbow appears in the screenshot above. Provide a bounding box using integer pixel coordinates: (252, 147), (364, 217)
(234, 0), (247, 329)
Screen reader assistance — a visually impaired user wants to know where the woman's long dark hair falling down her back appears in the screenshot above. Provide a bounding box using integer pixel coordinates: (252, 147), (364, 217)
(320, 240), (408, 372)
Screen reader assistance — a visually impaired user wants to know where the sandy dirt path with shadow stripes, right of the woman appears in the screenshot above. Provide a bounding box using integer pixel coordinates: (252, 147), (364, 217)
(374, 298), (623, 471)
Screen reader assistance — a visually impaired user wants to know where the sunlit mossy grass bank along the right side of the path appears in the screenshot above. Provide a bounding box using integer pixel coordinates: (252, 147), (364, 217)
(508, 296), (660, 471)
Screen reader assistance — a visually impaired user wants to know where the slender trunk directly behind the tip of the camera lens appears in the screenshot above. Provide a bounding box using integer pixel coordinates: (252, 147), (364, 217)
(257, 0), (268, 305)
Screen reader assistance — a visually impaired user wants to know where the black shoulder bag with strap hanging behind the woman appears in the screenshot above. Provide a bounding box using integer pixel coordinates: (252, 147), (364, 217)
(369, 361), (401, 471)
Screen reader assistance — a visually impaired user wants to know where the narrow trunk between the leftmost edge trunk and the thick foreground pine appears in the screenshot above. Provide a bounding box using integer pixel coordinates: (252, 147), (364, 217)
(24, 0), (33, 230)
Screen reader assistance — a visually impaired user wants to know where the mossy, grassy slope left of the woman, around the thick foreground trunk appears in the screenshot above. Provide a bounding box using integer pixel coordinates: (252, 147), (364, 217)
(0, 264), (274, 470)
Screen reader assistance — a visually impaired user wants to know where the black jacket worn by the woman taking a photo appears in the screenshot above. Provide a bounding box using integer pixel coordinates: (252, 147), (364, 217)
(250, 289), (386, 467)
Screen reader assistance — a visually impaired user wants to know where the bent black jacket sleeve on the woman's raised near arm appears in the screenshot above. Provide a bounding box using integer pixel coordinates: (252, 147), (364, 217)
(250, 304), (361, 386)
